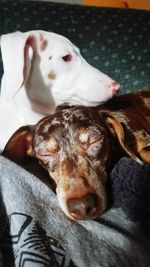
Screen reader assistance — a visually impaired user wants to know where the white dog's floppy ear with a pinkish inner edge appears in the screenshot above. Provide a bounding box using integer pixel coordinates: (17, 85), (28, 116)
(1, 32), (34, 100)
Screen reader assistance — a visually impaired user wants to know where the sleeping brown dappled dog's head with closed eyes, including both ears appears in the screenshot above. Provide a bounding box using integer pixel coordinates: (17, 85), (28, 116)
(3, 107), (142, 220)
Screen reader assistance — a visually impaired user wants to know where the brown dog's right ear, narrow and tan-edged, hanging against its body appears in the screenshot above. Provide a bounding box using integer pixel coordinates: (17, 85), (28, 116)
(99, 110), (143, 164)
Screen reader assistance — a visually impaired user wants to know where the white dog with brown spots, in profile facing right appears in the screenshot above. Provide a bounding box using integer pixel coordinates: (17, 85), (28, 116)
(0, 31), (120, 150)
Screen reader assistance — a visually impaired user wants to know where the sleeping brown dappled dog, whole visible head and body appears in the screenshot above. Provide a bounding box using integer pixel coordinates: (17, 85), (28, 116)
(3, 90), (150, 220)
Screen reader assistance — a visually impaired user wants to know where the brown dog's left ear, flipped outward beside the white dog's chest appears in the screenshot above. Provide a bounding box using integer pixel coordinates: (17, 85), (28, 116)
(2, 126), (34, 163)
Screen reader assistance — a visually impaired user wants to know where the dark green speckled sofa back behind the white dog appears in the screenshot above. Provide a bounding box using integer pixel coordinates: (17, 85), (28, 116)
(0, 0), (150, 93)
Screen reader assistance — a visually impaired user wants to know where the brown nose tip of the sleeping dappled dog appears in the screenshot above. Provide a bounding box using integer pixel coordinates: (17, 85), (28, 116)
(67, 193), (98, 220)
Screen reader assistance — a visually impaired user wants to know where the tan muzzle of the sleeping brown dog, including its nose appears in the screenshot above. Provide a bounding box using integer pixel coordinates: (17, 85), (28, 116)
(56, 159), (107, 220)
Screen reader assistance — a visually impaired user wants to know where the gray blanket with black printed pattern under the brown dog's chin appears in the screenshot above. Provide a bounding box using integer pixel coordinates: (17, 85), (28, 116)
(0, 156), (150, 267)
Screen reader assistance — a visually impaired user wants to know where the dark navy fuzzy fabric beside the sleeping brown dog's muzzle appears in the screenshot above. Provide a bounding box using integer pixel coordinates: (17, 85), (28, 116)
(111, 157), (150, 237)
